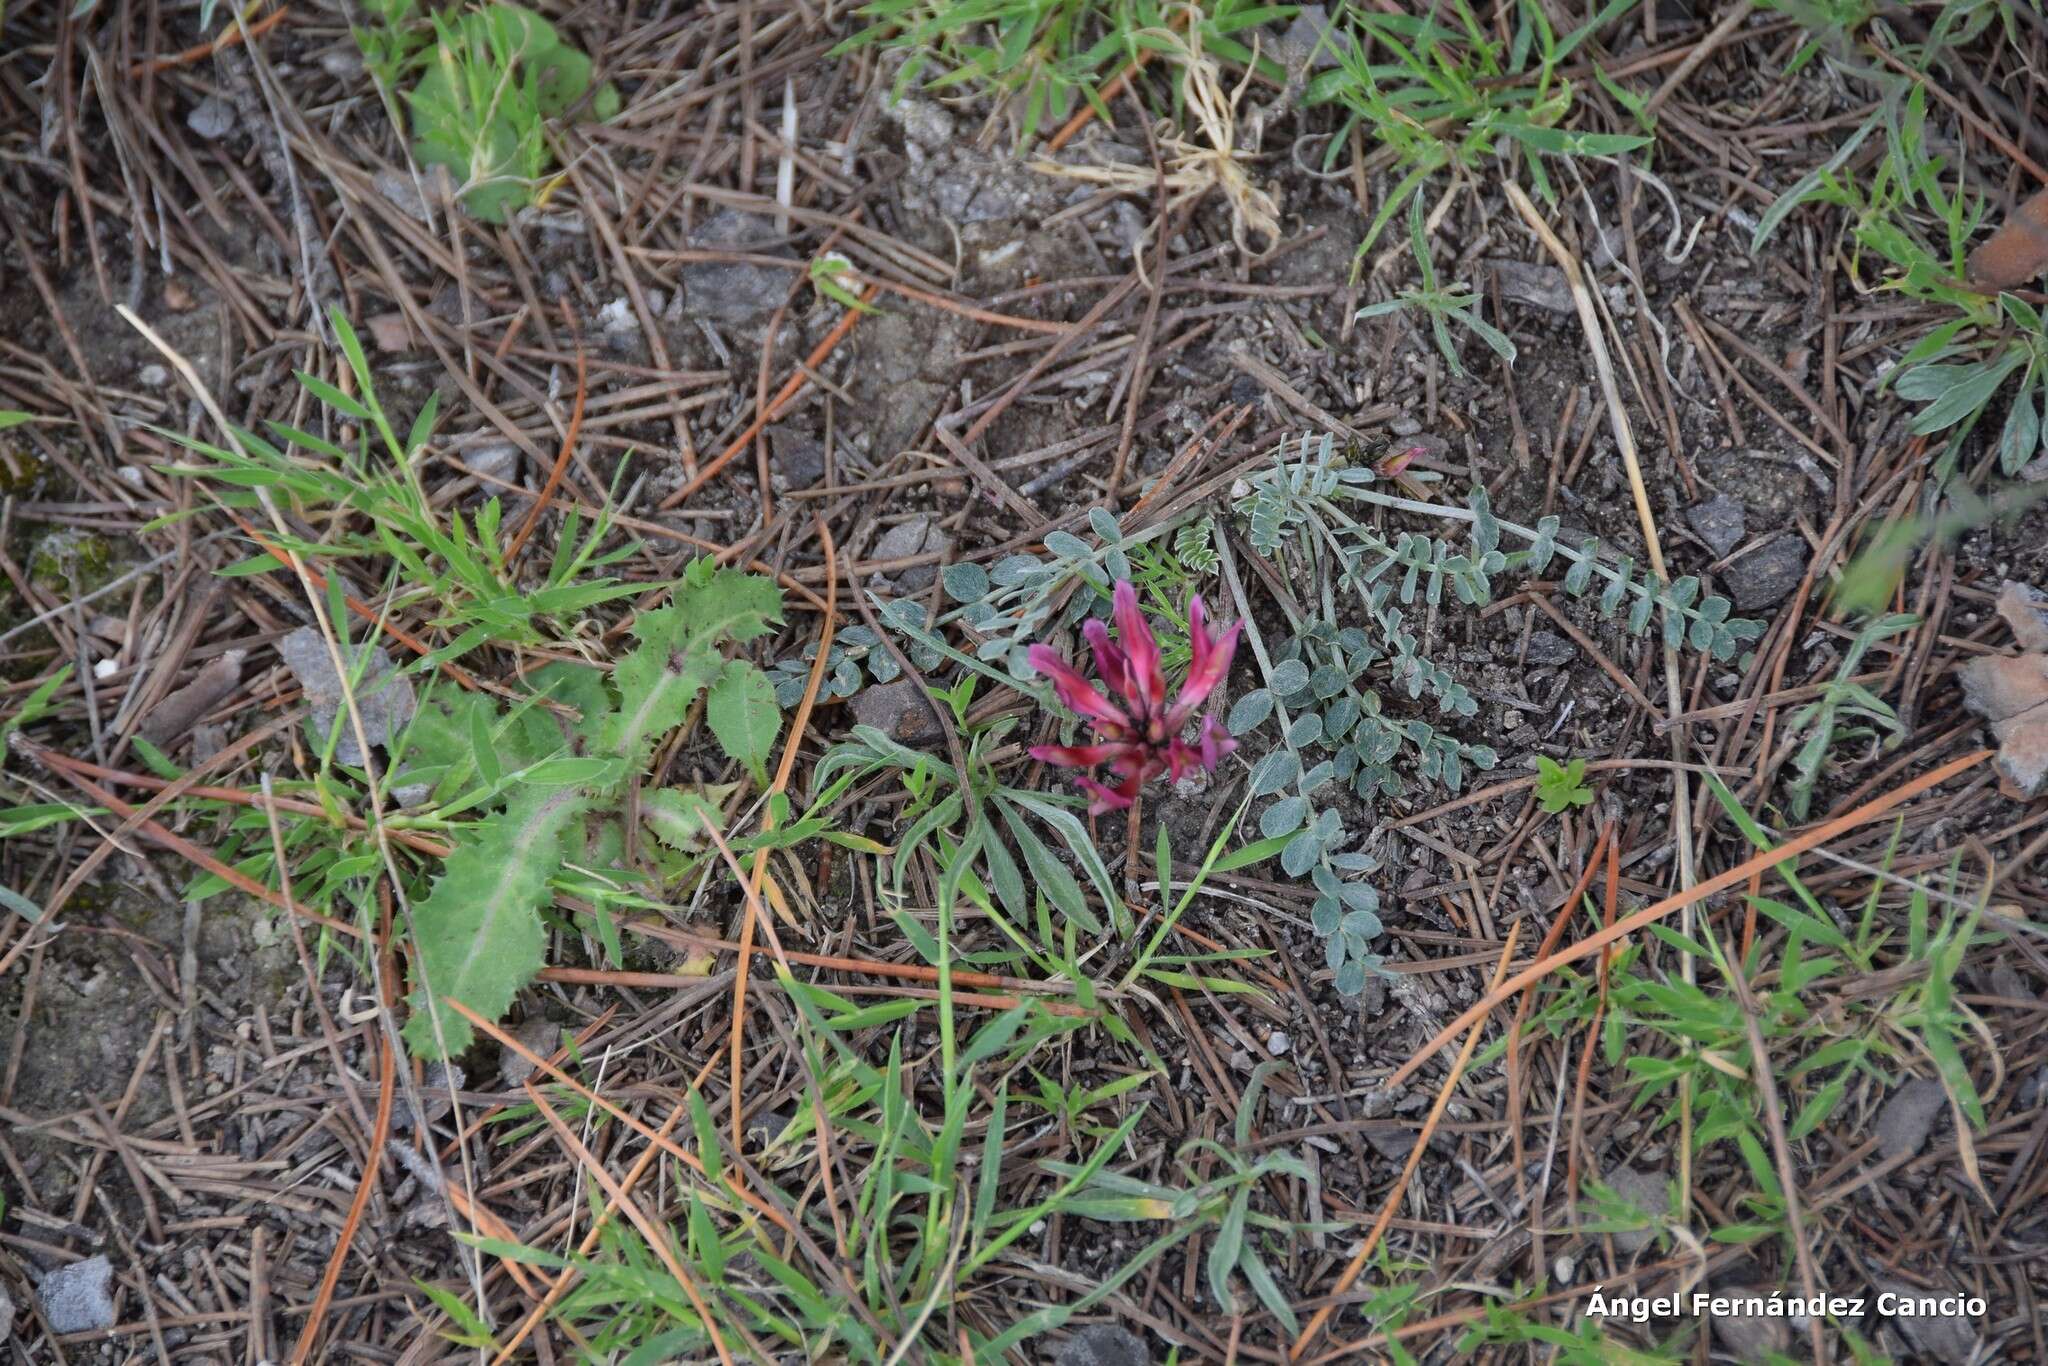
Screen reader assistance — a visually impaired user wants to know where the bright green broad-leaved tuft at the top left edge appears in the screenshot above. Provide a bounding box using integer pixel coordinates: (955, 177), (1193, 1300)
(352, 0), (618, 223)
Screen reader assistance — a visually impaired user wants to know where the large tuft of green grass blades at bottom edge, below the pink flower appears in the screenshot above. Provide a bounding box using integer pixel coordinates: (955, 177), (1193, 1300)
(477, 858), (1220, 1366)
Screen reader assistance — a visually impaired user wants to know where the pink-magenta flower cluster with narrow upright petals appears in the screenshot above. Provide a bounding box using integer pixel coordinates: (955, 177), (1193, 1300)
(1028, 582), (1243, 815)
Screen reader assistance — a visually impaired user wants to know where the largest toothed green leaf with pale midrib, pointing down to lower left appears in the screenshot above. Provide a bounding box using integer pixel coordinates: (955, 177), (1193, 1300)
(406, 788), (588, 1059)
